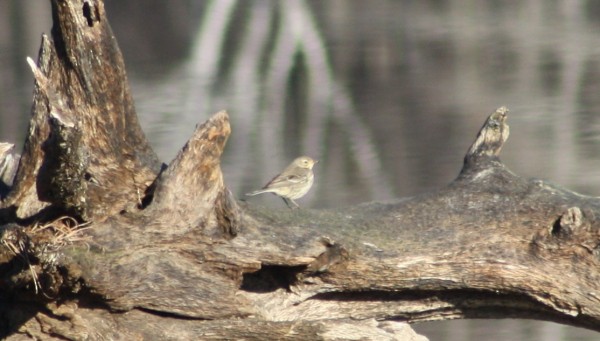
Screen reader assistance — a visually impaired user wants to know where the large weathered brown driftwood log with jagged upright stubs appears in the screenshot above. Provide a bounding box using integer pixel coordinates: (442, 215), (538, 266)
(0, 0), (600, 340)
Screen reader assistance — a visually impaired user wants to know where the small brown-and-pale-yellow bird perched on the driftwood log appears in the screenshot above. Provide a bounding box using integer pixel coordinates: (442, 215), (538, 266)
(246, 156), (319, 208)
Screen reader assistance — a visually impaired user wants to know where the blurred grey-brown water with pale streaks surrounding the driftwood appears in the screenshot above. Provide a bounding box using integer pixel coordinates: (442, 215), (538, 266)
(0, 0), (600, 341)
